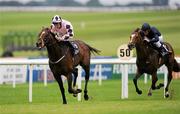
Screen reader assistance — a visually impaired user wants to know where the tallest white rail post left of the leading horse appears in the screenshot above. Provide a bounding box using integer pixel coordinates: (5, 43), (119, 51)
(29, 65), (33, 103)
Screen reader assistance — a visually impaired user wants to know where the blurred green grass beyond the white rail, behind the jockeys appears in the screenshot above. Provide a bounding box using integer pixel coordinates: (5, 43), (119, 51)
(0, 11), (180, 56)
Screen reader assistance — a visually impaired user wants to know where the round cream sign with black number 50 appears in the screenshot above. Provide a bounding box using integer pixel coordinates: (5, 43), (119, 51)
(117, 44), (133, 60)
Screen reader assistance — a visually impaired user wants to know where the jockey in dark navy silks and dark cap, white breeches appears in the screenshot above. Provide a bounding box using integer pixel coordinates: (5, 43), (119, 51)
(141, 23), (169, 57)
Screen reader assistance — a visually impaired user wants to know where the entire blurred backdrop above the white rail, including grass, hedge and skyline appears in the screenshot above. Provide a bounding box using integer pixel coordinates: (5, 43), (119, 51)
(0, 0), (180, 57)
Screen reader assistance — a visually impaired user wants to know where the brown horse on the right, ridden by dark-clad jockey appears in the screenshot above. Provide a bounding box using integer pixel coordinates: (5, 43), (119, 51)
(128, 28), (180, 97)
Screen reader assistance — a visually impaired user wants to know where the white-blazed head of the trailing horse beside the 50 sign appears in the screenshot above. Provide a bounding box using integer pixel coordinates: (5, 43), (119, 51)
(128, 28), (142, 50)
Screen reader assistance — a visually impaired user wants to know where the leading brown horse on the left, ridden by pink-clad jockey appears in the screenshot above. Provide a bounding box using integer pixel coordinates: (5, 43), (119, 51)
(36, 28), (100, 104)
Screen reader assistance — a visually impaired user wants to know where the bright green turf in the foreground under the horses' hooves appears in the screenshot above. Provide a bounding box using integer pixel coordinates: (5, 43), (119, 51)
(0, 80), (180, 114)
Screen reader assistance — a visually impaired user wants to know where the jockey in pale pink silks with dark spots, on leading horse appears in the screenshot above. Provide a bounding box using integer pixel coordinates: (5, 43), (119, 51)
(51, 15), (78, 56)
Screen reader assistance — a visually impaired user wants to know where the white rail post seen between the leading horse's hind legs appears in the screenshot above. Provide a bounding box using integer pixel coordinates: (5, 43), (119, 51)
(77, 66), (82, 101)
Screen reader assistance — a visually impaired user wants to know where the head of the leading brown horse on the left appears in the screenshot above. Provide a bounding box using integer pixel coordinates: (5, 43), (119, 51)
(36, 28), (55, 49)
